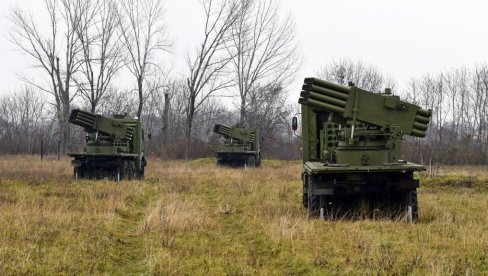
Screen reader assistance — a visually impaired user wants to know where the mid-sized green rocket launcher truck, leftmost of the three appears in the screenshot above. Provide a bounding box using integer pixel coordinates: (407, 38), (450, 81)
(68, 109), (147, 182)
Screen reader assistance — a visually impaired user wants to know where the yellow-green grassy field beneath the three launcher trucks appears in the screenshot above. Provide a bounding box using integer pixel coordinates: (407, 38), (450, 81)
(0, 156), (488, 275)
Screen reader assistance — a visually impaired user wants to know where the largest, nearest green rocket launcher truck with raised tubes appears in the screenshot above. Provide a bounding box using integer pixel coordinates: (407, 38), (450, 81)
(292, 78), (432, 222)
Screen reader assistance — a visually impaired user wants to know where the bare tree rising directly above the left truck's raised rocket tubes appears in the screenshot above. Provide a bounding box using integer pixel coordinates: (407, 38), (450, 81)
(75, 0), (123, 112)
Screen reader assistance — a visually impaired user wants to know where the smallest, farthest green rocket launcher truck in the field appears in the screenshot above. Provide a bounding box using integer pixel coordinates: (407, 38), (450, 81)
(214, 124), (261, 167)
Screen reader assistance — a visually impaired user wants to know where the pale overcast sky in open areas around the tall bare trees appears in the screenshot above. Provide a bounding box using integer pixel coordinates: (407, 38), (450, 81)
(0, 0), (488, 97)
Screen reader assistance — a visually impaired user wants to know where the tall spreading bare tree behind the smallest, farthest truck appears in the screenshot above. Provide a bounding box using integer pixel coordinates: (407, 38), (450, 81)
(228, 0), (301, 123)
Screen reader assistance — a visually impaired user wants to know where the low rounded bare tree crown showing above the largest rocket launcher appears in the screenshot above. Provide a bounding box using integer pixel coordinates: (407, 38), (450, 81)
(317, 58), (386, 92)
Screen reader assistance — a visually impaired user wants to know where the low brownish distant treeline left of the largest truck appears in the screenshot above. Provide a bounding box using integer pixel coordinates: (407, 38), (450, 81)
(0, 87), (300, 159)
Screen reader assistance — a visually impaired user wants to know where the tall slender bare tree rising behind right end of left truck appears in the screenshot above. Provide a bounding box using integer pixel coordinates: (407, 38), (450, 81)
(118, 0), (171, 118)
